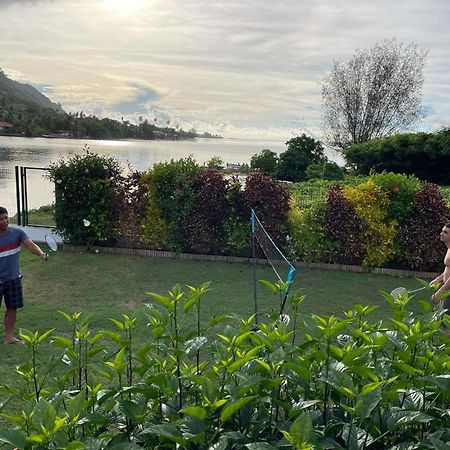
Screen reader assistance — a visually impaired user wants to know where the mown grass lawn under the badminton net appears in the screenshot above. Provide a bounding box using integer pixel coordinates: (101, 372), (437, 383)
(0, 250), (432, 383)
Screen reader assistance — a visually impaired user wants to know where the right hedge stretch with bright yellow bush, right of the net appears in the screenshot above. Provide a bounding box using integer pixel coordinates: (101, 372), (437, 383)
(289, 173), (450, 270)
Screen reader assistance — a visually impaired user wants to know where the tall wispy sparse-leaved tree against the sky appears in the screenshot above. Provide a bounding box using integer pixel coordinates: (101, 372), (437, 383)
(322, 39), (427, 148)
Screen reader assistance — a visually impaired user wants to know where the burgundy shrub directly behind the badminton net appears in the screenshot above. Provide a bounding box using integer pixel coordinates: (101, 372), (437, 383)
(244, 173), (289, 247)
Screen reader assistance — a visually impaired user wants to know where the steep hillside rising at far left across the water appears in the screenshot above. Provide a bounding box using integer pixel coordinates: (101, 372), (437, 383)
(0, 69), (64, 115)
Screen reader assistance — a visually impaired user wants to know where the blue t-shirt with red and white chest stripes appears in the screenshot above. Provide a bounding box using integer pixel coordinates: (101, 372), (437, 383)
(0, 227), (28, 281)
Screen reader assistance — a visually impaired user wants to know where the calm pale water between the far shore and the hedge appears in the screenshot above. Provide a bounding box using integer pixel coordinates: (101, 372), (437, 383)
(0, 136), (339, 216)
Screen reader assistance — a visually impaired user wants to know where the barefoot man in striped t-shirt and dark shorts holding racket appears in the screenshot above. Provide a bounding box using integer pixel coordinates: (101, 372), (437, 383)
(0, 206), (47, 344)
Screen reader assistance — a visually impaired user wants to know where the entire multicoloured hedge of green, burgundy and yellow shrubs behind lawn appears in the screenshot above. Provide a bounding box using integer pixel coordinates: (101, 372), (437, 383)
(50, 152), (450, 271)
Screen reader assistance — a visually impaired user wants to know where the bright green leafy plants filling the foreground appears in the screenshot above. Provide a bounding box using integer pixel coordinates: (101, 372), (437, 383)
(0, 283), (450, 450)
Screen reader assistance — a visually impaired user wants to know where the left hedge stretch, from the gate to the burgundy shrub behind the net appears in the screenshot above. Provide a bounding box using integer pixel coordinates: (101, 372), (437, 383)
(49, 151), (289, 256)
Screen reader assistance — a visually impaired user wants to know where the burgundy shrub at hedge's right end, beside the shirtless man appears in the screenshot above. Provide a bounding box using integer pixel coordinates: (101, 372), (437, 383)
(399, 184), (450, 270)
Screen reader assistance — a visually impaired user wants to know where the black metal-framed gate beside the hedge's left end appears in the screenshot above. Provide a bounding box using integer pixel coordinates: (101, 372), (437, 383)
(15, 166), (55, 227)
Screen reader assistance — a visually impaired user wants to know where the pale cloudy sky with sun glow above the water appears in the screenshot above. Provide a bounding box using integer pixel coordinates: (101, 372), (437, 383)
(0, 0), (450, 140)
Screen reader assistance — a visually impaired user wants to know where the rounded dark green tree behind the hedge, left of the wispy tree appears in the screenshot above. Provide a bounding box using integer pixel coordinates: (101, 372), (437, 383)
(276, 134), (326, 182)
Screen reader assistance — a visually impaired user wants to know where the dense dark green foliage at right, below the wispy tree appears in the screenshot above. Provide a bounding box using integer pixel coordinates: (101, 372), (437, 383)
(344, 129), (450, 185)
